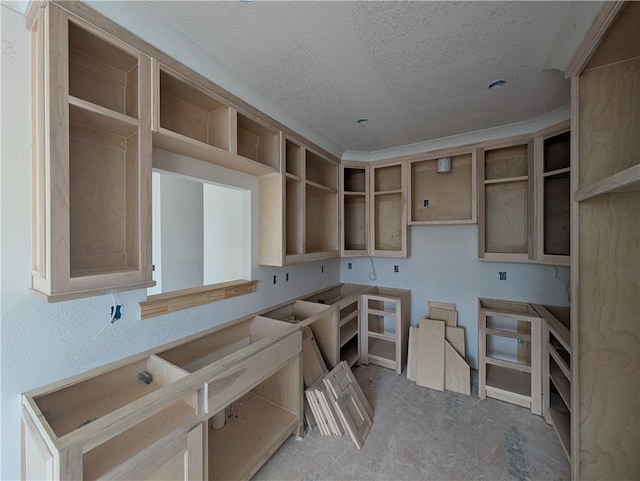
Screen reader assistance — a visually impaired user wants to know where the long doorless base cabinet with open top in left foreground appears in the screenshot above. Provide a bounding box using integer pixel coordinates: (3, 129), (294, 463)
(22, 317), (302, 480)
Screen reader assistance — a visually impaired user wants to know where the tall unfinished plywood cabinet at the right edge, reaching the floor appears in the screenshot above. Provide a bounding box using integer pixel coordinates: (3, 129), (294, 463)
(568, 2), (640, 479)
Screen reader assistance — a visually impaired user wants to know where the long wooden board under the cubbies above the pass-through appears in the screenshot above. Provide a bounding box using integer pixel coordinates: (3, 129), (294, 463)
(153, 128), (278, 176)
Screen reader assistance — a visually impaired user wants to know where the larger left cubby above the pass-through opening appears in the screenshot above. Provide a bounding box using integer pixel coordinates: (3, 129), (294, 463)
(160, 69), (229, 151)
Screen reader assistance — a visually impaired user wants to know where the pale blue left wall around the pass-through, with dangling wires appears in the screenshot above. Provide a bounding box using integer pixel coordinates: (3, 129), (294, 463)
(0, 8), (340, 479)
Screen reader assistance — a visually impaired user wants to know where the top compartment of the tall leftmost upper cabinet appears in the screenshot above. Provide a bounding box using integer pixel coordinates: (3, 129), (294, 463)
(69, 21), (138, 118)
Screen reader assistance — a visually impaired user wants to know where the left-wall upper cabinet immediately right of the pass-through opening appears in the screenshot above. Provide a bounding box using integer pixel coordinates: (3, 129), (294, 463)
(259, 137), (339, 266)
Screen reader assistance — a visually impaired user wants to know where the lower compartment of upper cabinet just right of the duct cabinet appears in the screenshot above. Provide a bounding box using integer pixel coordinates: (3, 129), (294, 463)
(484, 180), (529, 254)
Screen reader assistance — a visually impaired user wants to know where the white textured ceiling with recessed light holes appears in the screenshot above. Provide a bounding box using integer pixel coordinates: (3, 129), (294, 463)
(139, 1), (596, 152)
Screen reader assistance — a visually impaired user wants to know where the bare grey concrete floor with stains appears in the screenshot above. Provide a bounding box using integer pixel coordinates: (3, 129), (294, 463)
(254, 365), (570, 481)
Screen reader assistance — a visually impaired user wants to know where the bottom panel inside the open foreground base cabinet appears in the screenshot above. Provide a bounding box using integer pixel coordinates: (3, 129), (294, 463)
(208, 393), (298, 480)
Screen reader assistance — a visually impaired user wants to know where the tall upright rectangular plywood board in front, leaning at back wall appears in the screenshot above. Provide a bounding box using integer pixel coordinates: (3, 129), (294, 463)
(416, 319), (445, 391)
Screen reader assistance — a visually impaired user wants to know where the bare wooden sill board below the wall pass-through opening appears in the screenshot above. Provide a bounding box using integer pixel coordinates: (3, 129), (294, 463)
(140, 280), (258, 319)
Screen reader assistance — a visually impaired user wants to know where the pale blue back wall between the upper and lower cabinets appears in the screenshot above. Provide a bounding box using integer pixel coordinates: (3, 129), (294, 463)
(340, 225), (569, 368)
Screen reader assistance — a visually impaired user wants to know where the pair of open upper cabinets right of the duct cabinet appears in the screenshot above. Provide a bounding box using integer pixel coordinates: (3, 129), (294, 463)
(478, 121), (571, 266)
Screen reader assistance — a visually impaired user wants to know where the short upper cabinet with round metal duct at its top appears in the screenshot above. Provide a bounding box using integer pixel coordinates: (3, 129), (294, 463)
(408, 149), (477, 225)
